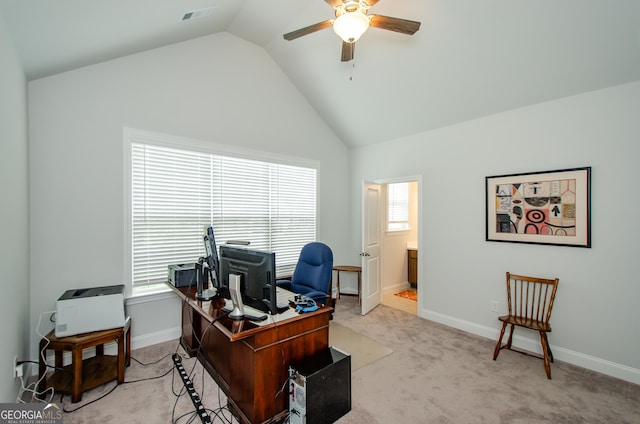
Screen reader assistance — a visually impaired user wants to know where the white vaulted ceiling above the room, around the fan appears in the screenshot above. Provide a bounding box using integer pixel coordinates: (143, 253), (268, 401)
(0, 0), (640, 148)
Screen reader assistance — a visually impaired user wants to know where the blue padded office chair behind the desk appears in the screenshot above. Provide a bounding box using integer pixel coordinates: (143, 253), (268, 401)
(276, 241), (333, 305)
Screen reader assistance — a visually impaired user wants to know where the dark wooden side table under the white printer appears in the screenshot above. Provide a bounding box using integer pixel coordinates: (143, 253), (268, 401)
(38, 318), (131, 403)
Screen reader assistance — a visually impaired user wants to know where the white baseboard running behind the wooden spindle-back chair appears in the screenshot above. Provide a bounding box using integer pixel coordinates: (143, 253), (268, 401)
(419, 309), (640, 384)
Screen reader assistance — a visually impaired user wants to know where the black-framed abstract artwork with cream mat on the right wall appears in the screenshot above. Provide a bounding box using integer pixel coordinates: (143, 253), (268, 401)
(485, 167), (591, 247)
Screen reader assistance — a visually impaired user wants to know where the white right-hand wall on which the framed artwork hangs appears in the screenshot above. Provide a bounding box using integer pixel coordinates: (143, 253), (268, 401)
(351, 82), (640, 383)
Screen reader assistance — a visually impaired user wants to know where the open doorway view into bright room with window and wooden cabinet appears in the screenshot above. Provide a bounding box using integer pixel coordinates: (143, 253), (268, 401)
(381, 178), (423, 315)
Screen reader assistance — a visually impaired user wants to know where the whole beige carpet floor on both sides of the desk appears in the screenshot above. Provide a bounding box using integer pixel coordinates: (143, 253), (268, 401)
(36, 297), (640, 424)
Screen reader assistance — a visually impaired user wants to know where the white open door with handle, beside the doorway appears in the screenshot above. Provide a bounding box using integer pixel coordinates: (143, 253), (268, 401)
(360, 182), (382, 315)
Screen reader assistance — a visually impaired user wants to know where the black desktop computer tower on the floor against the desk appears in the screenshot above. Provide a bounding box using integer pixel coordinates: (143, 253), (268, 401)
(289, 347), (351, 424)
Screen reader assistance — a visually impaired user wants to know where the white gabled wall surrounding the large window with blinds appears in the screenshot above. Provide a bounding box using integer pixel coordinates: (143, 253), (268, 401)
(29, 33), (348, 356)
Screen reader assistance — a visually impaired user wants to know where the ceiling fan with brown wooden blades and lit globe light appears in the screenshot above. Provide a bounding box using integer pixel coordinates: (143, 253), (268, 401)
(283, 0), (420, 62)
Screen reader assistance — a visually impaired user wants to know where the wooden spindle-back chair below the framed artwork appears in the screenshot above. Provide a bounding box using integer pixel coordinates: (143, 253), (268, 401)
(493, 272), (558, 379)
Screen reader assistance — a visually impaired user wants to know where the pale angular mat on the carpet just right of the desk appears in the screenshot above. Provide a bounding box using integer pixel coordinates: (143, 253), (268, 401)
(329, 321), (393, 372)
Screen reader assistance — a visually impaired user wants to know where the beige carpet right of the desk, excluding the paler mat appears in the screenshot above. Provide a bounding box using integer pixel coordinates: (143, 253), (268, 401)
(334, 299), (640, 424)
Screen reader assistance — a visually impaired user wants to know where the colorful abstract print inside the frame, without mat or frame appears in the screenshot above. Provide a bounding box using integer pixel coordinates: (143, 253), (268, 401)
(496, 179), (576, 236)
